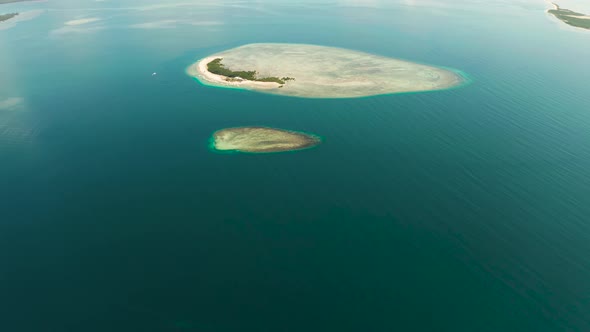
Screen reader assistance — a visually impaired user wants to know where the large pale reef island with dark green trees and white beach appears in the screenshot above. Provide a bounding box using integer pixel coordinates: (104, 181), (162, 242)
(187, 43), (466, 98)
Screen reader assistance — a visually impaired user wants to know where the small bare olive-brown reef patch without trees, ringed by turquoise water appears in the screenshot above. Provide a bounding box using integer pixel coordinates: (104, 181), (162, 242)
(212, 127), (321, 153)
